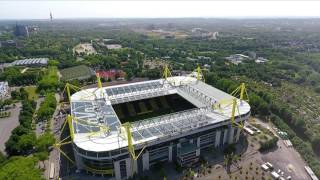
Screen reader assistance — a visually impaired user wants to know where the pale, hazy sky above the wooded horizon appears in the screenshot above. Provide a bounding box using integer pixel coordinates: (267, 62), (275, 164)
(0, 0), (320, 19)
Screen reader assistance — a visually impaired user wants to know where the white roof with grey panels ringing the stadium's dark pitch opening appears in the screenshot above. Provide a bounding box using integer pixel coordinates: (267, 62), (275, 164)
(71, 76), (250, 152)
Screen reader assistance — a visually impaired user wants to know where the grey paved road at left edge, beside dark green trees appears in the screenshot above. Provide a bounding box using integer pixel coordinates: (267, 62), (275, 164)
(0, 102), (21, 154)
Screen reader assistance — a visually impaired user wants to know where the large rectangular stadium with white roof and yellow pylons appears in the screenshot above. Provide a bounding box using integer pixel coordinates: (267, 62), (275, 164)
(67, 72), (250, 179)
